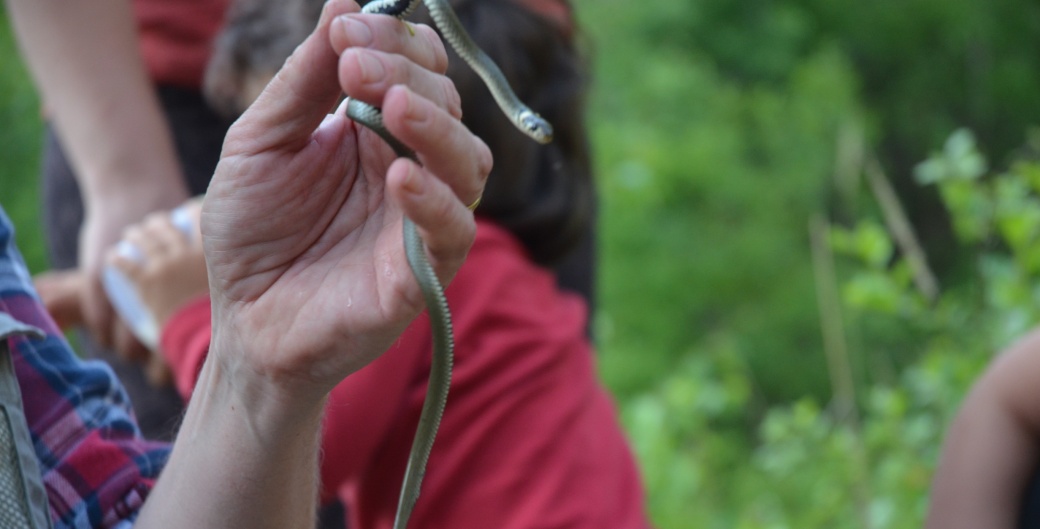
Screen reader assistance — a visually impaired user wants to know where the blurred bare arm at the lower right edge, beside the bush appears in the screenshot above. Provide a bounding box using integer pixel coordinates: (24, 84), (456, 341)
(926, 330), (1040, 529)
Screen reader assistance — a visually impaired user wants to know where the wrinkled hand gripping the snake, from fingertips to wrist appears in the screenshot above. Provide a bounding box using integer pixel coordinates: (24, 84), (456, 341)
(202, 0), (491, 398)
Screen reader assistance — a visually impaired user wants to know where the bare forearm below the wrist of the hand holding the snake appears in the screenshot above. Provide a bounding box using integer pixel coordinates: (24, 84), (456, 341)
(135, 338), (324, 529)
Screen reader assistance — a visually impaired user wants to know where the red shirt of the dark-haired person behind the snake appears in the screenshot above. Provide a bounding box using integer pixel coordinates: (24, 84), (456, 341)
(162, 221), (649, 529)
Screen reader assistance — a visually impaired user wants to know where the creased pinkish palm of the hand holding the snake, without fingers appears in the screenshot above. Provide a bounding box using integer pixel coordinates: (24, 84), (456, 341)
(204, 117), (421, 377)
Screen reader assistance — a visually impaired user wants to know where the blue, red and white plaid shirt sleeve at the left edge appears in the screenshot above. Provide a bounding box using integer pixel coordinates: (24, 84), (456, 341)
(0, 207), (170, 529)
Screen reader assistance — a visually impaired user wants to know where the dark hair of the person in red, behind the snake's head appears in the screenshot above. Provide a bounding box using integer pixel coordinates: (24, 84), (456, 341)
(413, 0), (595, 266)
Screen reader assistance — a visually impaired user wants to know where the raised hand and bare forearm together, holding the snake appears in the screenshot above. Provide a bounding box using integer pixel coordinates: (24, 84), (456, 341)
(136, 0), (491, 529)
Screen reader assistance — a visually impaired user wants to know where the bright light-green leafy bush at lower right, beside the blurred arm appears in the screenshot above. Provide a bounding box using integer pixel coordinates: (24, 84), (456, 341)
(623, 131), (1040, 529)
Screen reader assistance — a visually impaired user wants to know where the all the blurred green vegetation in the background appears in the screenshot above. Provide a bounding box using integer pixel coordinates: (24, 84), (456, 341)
(0, 0), (1040, 529)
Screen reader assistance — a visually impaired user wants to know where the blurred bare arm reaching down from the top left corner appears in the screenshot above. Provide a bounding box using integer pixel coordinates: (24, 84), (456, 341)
(6, 0), (187, 348)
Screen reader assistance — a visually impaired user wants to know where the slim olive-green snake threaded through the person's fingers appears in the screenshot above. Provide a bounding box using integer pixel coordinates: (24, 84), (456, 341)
(346, 0), (552, 529)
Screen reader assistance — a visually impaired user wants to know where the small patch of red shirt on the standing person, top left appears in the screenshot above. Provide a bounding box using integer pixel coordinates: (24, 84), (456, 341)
(133, 0), (231, 88)
